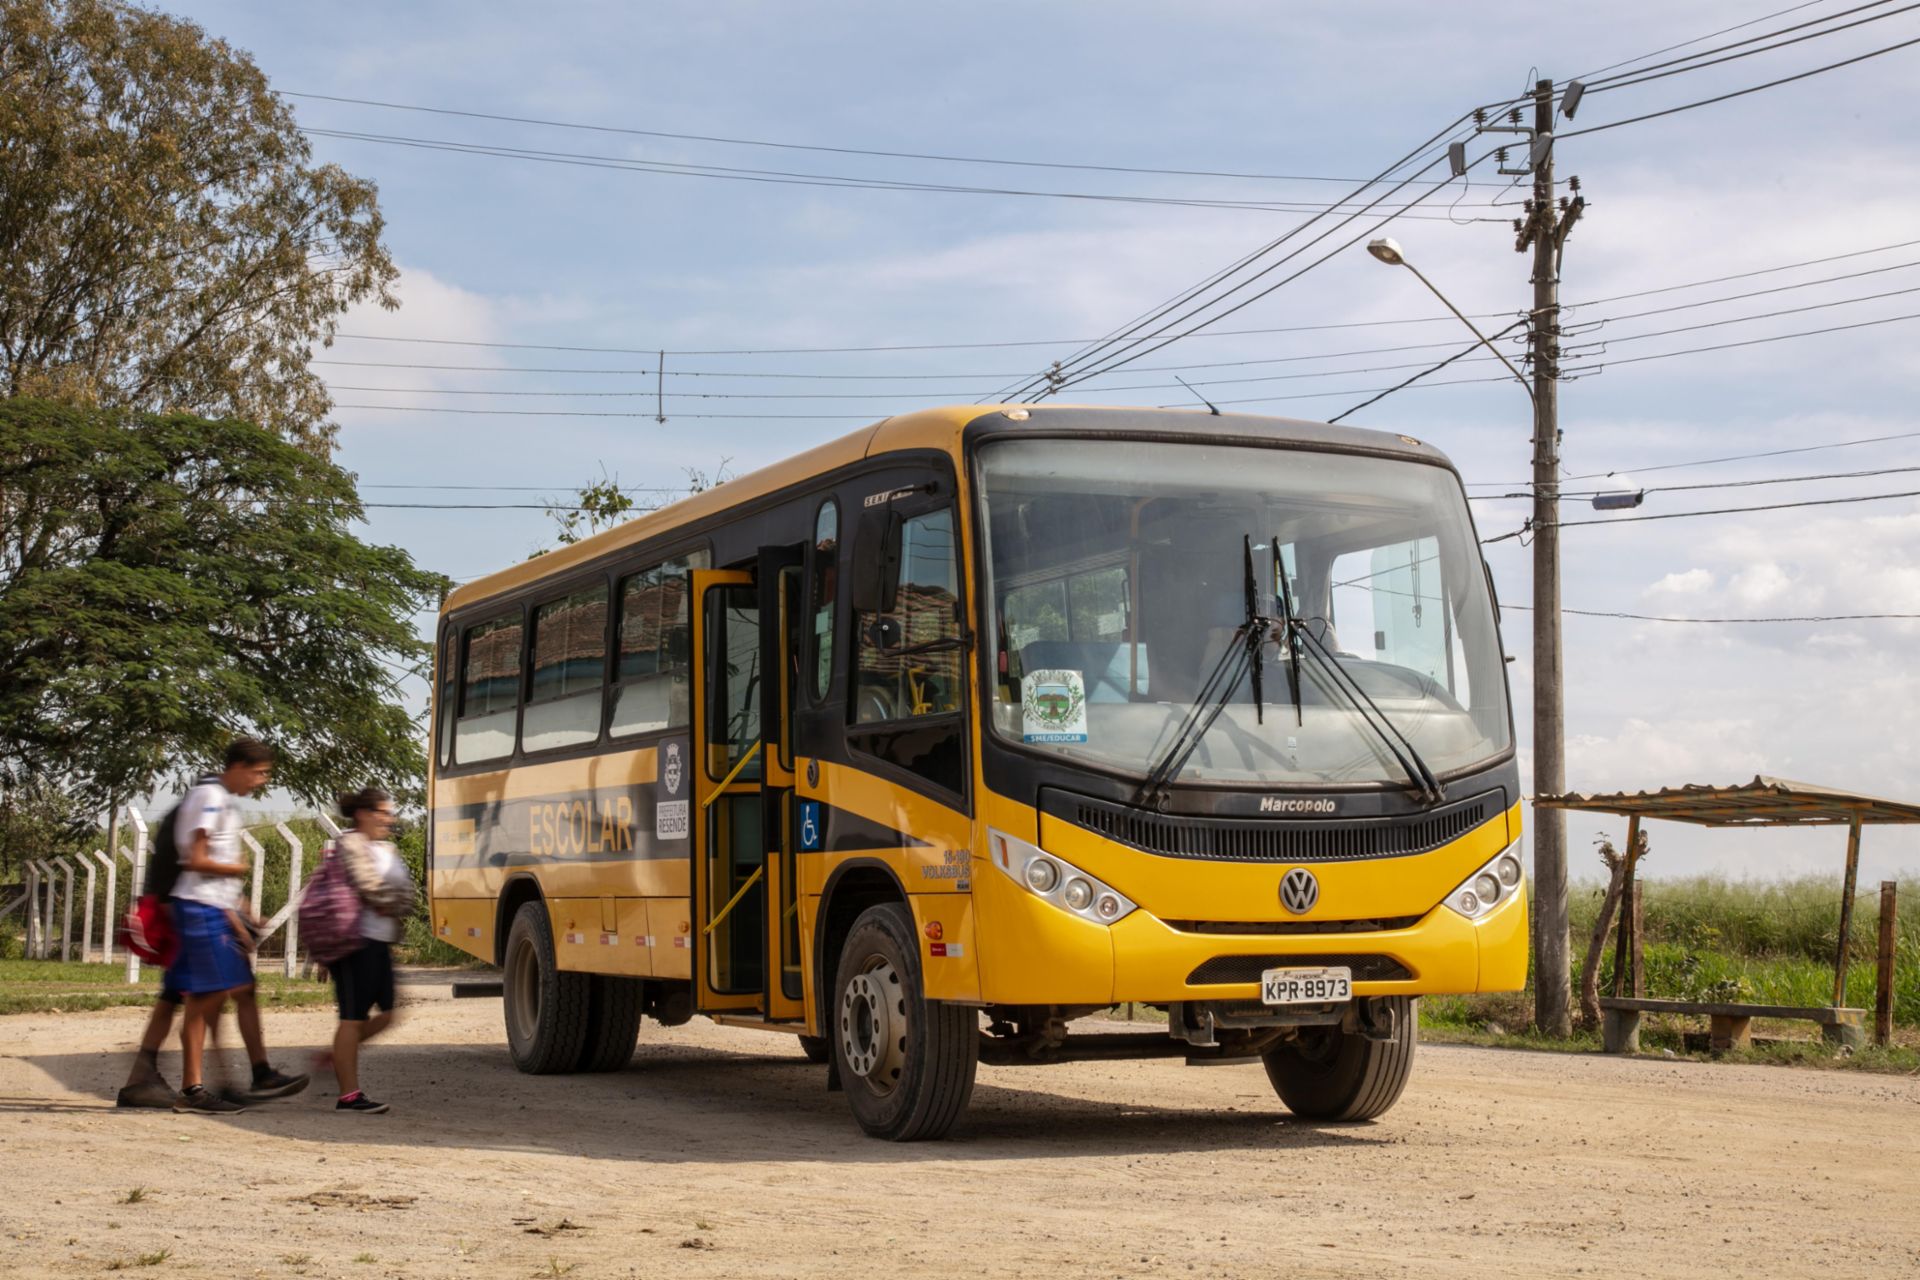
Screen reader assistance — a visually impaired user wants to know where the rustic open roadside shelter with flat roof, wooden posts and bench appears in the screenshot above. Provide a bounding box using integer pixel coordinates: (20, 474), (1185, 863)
(1534, 775), (1920, 1048)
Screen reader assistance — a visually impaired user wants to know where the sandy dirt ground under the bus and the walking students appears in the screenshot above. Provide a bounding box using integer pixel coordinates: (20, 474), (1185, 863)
(0, 974), (1920, 1280)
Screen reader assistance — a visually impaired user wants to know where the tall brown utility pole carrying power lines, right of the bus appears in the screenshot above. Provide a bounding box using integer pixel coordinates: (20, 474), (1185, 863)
(1515, 81), (1586, 1036)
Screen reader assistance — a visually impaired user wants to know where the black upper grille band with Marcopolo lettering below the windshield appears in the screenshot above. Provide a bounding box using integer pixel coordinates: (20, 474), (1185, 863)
(1041, 789), (1501, 862)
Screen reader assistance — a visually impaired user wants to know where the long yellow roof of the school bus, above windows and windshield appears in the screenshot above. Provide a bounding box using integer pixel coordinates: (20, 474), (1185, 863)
(440, 401), (1450, 614)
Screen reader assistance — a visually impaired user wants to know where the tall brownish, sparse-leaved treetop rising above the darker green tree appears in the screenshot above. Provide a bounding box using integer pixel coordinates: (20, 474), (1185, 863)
(0, 0), (397, 451)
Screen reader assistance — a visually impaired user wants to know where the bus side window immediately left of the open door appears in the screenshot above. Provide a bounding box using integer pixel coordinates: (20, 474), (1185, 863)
(612, 551), (708, 737)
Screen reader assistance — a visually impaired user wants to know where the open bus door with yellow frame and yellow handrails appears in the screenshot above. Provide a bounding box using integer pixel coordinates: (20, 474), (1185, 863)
(691, 549), (804, 1021)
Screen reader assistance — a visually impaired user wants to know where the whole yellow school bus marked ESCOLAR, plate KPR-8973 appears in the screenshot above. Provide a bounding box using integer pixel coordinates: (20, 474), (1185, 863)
(430, 405), (1526, 1140)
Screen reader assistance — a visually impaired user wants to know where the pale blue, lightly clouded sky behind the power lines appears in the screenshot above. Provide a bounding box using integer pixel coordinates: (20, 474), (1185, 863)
(173, 0), (1920, 879)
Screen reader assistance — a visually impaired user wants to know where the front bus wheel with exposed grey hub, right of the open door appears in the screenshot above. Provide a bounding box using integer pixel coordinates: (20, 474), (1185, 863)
(828, 902), (979, 1142)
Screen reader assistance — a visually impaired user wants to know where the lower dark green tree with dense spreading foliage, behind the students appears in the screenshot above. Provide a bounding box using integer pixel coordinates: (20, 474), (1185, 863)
(0, 397), (445, 812)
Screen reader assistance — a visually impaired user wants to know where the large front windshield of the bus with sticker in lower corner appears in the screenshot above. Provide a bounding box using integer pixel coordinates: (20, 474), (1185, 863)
(977, 439), (1511, 785)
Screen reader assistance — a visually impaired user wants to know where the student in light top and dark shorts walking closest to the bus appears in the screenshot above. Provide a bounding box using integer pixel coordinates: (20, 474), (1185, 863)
(326, 787), (413, 1115)
